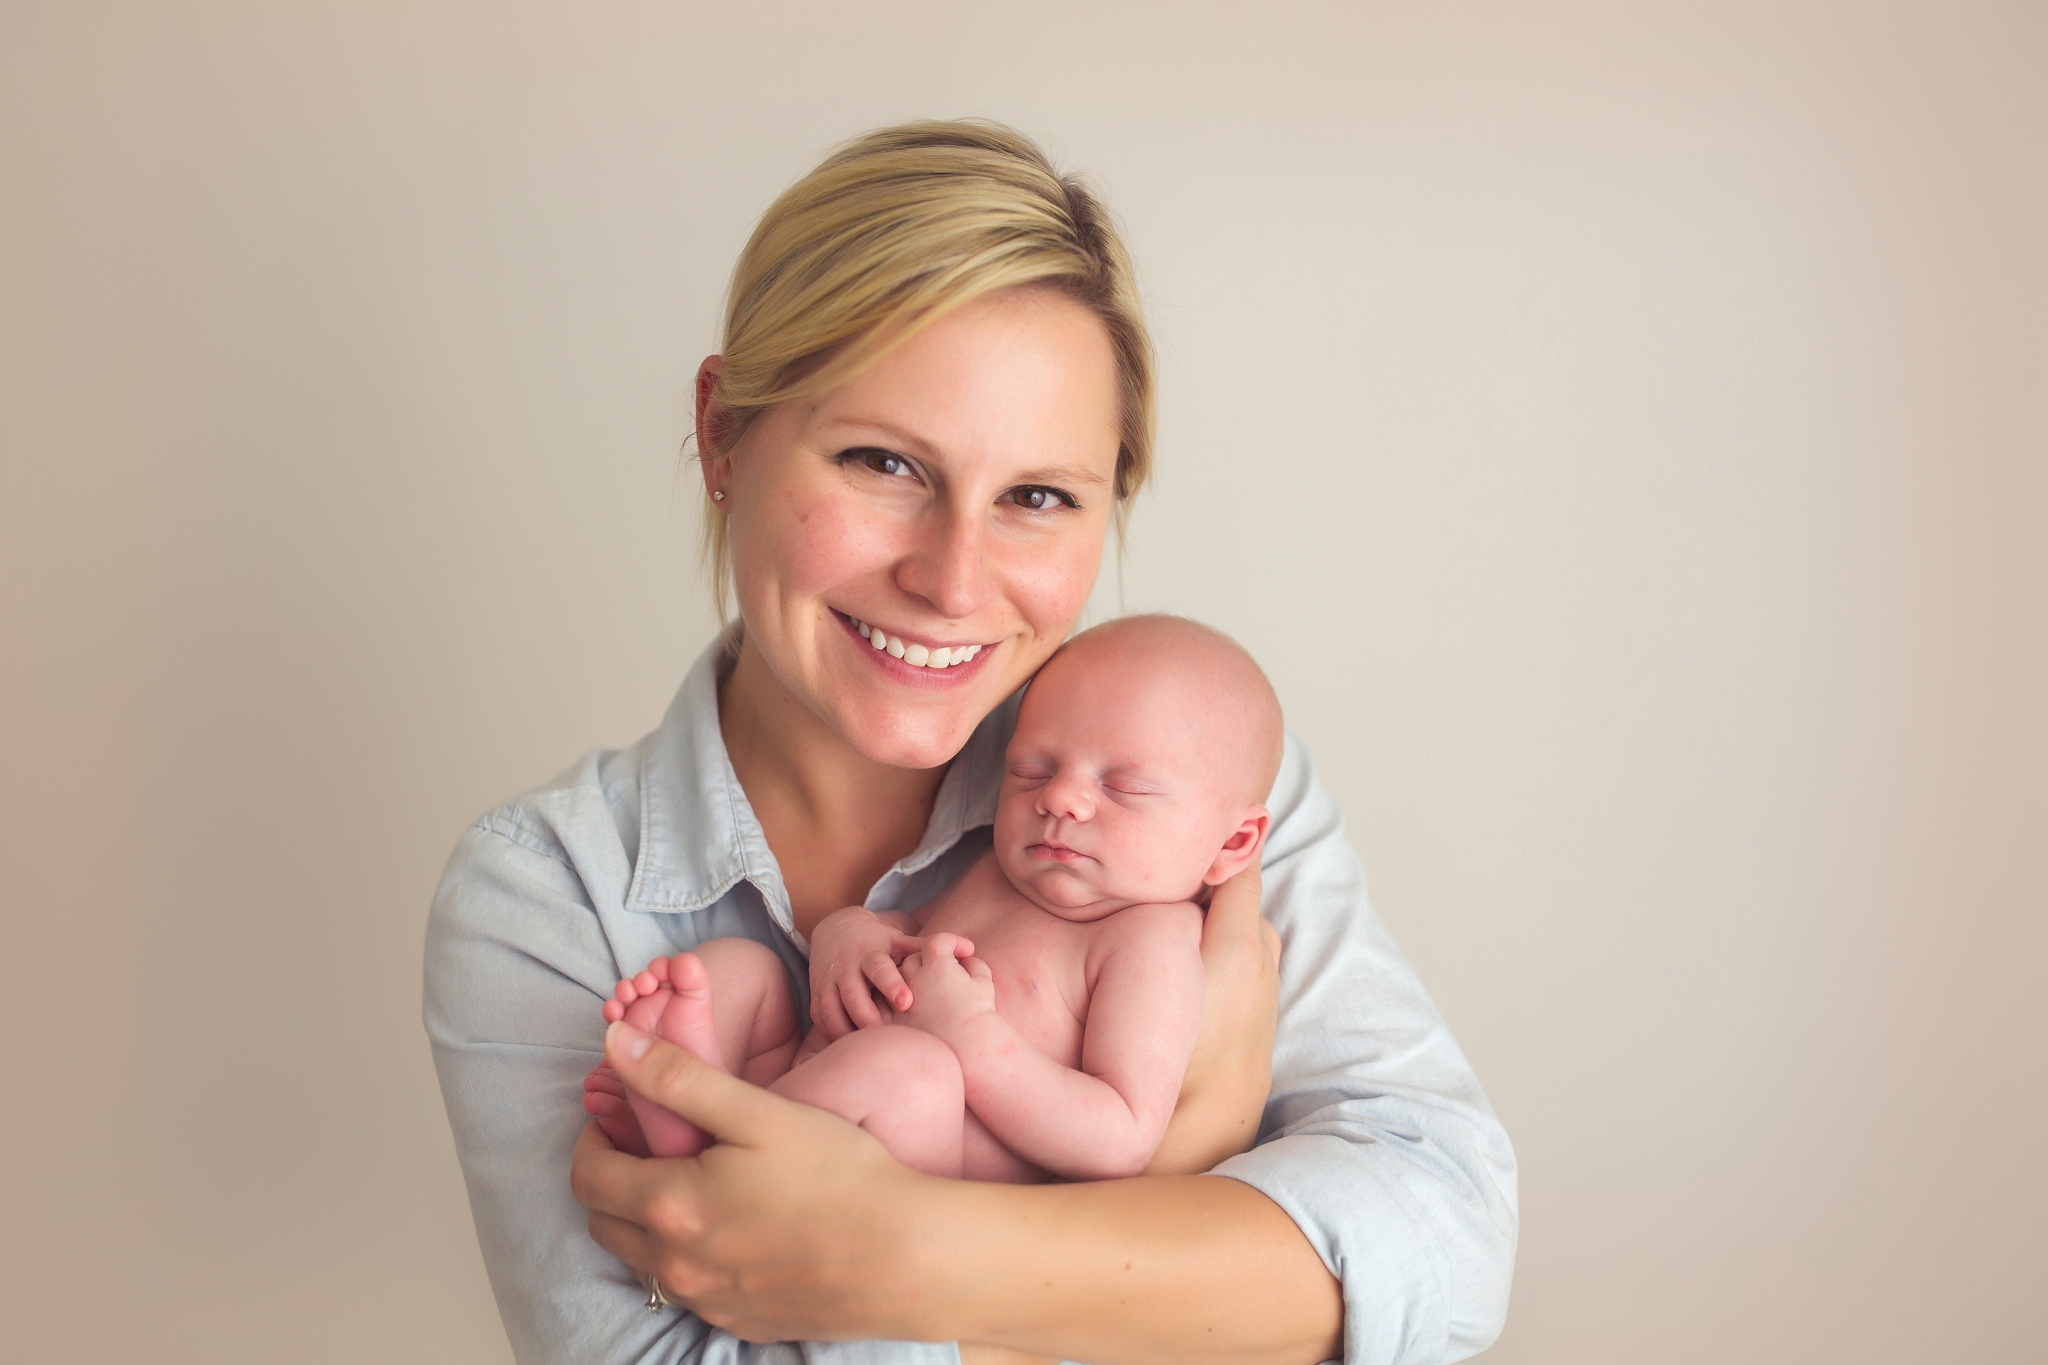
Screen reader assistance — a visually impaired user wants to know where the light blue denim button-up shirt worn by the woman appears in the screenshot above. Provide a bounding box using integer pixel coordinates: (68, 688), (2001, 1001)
(426, 645), (1516, 1365)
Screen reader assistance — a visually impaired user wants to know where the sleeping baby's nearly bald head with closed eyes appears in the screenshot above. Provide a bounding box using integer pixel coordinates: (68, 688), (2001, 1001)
(995, 616), (1282, 921)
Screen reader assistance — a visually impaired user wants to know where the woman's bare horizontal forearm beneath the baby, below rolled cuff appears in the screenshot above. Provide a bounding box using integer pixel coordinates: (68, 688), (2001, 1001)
(905, 1177), (1343, 1365)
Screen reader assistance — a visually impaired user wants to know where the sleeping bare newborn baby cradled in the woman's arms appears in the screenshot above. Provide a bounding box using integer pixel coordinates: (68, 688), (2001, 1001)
(584, 616), (1280, 1181)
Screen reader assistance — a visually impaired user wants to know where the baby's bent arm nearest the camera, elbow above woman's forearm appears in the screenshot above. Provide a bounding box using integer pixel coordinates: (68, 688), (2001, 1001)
(905, 905), (1202, 1181)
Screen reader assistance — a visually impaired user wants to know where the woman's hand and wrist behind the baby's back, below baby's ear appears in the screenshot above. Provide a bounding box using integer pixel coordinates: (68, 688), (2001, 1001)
(1145, 864), (1280, 1175)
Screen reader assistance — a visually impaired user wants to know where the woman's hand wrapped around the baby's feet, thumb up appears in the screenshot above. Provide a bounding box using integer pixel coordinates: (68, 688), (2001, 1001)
(569, 1023), (938, 1340)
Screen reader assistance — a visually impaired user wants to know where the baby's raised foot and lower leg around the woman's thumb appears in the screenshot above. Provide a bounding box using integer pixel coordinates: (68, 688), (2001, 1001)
(584, 939), (799, 1156)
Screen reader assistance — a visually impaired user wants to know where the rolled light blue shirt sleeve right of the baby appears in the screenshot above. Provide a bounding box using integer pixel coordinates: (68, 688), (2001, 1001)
(1217, 735), (1518, 1365)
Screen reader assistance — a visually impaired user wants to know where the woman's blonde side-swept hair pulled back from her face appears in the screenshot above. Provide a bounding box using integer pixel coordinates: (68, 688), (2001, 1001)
(700, 119), (1153, 620)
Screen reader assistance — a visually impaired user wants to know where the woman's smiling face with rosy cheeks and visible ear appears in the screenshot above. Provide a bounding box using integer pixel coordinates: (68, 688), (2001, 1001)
(705, 289), (1118, 767)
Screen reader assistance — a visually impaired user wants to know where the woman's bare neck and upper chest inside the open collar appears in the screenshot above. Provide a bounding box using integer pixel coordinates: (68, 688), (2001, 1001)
(719, 641), (946, 937)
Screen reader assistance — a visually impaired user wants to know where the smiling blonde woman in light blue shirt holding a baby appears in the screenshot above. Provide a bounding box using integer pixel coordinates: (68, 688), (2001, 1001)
(426, 123), (1516, 1363)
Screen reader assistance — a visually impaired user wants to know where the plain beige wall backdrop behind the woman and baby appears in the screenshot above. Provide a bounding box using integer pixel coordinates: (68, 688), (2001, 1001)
(0, 0), (2048, 1365)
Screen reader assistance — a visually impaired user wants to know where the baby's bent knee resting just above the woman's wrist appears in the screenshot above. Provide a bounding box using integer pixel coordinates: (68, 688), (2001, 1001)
(768, 1023), (967, 1179)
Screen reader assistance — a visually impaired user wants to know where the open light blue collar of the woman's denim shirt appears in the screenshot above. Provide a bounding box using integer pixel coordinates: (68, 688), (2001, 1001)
(625, 639), (1022, 931)
